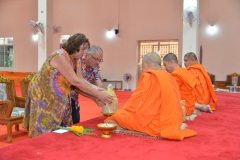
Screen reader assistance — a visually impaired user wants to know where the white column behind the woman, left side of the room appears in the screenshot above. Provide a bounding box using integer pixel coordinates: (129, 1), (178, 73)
(38, 0), (53, 70)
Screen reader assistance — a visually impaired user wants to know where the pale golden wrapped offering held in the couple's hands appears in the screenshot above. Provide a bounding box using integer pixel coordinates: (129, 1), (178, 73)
(102, 84), (118, 117)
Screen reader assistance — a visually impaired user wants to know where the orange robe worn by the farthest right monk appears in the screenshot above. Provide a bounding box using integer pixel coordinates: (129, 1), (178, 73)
(187, 64), (218, 110)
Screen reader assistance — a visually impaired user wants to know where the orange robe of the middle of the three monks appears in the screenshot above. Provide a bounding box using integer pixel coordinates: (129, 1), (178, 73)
(171, 68), (196, 116)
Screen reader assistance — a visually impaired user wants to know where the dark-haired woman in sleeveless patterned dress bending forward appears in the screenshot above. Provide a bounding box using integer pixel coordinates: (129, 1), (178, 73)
(23, 33), (112, 137)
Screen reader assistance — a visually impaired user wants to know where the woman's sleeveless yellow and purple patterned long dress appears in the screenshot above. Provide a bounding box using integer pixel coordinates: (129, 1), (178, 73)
(23, 49), (78, 137)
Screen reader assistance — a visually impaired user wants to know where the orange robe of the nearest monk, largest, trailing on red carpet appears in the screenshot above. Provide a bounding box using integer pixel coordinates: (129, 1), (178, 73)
(106, 70), (196, 140)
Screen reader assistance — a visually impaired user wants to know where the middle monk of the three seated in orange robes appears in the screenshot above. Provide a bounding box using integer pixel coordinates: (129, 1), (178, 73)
(163, 53), (212, 116)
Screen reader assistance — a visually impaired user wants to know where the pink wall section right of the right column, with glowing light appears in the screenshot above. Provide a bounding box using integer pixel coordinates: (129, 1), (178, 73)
(199, 0), (240, 81)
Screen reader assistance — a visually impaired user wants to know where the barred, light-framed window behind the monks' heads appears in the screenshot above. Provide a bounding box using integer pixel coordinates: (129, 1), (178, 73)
(138, 40), (178, 77)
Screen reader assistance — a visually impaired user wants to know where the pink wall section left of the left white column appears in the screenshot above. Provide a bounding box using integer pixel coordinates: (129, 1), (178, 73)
(0, 0), (38, 72)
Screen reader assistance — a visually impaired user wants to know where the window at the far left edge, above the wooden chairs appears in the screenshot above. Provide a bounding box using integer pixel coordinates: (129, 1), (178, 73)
(0, 37), (13, 67)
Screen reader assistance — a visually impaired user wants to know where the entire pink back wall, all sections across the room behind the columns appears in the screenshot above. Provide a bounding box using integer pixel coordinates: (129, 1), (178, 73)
(0, 0), (240, 89)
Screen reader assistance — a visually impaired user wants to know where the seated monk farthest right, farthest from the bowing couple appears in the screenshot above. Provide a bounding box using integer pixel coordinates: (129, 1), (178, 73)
(184, 52), (218, 112)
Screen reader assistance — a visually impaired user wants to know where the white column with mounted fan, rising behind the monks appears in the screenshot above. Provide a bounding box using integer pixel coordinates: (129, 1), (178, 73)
(182, 0), (199, 67)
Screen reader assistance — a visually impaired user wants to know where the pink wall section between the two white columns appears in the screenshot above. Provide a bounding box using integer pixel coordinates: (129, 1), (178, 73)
(53, 0), (182, 88)
